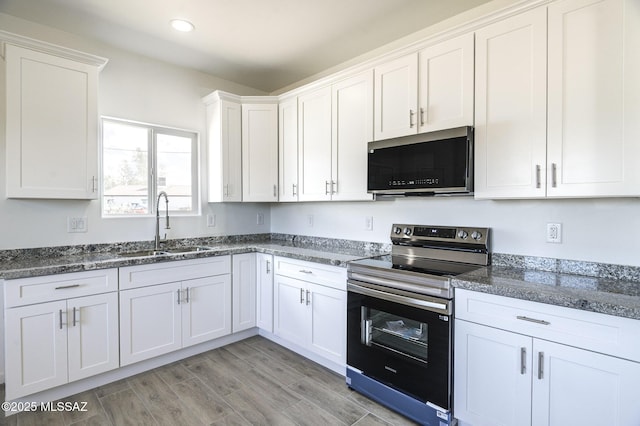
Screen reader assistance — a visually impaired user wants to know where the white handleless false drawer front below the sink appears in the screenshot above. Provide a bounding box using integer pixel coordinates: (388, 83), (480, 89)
(120, 256), (231, 289)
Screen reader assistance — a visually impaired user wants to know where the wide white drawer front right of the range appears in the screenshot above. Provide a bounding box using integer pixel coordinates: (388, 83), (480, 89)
(455, 289), (640, 361)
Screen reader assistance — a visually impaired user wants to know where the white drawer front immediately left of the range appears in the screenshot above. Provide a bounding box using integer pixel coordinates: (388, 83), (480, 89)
(274, 257), (347, 291)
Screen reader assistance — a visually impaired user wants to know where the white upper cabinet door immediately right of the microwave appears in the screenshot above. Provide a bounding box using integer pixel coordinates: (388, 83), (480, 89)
(474, 7), (547, 198)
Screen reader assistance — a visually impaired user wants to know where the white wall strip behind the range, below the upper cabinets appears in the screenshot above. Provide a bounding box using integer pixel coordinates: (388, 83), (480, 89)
(271, 197), (640, 266)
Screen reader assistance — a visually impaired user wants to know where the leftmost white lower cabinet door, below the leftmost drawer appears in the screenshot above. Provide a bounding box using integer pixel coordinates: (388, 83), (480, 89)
(5, 300), (67, 401)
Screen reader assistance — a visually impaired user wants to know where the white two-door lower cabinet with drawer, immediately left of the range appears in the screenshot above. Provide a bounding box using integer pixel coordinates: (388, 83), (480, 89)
(273, 257), (347, 365)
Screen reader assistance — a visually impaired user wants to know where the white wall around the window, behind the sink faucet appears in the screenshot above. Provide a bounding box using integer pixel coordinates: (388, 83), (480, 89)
(0, 14), (270, 249)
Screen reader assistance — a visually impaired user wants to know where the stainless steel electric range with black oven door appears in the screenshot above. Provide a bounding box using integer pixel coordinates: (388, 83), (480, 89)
(347, 225), (490, 426)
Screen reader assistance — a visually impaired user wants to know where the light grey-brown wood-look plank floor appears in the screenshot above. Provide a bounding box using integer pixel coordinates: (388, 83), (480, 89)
(0, 336), (414, 426)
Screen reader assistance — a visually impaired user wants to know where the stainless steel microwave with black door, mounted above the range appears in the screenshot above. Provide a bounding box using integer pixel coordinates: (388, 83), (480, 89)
(367, 126), (473, 196)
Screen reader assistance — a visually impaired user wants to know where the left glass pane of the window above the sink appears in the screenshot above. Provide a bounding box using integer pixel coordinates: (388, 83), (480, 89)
(102, 120), (150, 215)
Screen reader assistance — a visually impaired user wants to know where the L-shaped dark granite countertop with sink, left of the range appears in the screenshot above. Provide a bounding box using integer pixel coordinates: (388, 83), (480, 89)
(0, 235), (386, 280)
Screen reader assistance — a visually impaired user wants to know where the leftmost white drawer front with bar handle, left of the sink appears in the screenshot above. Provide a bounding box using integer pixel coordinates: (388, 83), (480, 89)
(4, 268), (118, 307)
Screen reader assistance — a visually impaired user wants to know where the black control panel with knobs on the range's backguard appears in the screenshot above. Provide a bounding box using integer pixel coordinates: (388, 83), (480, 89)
(391, 224), (489, 245)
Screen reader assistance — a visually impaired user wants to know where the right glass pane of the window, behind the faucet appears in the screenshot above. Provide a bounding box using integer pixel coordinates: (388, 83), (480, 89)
(156, 133), (193, 212)
